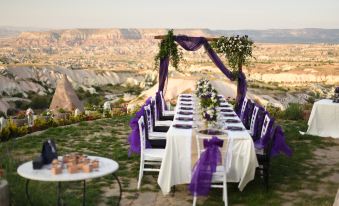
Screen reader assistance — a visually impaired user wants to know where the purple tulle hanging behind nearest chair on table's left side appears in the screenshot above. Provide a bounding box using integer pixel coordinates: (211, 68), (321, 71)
(128, 98), (151, 156)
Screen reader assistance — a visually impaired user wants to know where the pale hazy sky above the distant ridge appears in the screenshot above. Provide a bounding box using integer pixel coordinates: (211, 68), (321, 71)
(0, 0), (339, 30)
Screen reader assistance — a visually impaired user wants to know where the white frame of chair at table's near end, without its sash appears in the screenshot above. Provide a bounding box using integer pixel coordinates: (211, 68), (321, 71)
(193, 134), (233, 206)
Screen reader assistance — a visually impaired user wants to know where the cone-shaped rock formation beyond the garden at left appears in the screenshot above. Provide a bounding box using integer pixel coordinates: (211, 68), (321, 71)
(49, 74), (85, 112)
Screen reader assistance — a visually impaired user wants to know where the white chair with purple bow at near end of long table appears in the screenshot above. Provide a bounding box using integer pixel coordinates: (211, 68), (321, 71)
(189, 135), (233, 206)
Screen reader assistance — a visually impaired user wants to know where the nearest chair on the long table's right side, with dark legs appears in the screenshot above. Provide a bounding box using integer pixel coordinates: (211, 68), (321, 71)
(254, 112), (275, 190)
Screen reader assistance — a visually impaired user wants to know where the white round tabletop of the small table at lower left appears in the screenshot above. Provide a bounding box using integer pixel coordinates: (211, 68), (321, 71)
(17, 156), (119, 182)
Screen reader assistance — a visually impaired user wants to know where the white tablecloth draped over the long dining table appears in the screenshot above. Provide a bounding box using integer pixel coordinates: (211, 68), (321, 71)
(158, 97), (258, 195)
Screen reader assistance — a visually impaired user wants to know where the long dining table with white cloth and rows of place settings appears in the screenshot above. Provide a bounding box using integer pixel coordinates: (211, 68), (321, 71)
(158, 94), (258, 195)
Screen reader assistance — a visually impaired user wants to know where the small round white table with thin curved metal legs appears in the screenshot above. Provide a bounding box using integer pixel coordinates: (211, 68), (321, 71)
(17, 156), (122, 206)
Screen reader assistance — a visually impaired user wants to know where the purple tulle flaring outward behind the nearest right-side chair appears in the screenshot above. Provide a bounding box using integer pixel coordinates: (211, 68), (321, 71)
(271, 125), (292, 156)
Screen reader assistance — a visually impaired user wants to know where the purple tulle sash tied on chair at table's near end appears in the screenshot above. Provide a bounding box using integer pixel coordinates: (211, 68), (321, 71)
(189, 136), (224, 196)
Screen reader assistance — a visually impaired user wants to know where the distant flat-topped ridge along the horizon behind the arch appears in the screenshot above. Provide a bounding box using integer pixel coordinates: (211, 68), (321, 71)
(0, 26), (339, 44)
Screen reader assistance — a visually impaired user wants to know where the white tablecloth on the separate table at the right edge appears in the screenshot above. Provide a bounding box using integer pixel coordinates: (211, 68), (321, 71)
(307, 99), (339, 138)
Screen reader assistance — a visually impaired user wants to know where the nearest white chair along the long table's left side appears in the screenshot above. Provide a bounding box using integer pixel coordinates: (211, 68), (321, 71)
(137, 116), (165, 190)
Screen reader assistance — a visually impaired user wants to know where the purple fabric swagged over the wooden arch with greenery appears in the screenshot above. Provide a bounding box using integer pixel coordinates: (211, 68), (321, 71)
(158, 35), (247, 105)
